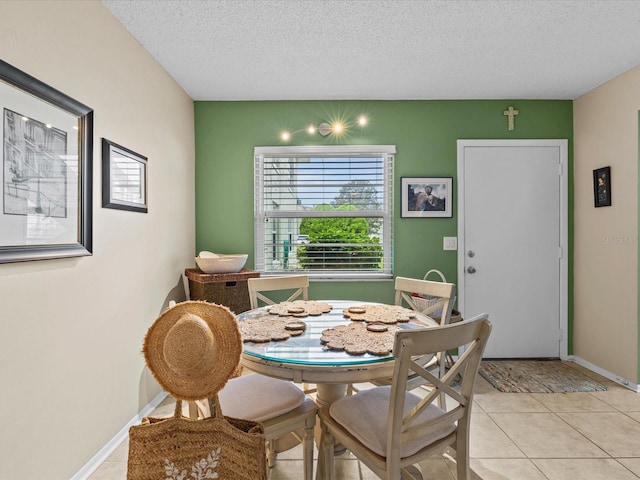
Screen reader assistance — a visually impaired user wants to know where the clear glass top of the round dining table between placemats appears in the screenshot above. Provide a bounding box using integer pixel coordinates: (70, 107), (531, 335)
(238, 300), (435, 366)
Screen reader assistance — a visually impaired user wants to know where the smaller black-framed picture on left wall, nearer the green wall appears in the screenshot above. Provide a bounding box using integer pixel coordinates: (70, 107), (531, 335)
(102, 138), (148, 213)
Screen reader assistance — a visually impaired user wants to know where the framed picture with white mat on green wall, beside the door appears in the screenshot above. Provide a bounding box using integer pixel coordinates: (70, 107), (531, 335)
(400, 177), (453, 218)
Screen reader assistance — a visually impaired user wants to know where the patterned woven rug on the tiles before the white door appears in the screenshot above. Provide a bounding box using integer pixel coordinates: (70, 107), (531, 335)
(479, 360), (607, 393)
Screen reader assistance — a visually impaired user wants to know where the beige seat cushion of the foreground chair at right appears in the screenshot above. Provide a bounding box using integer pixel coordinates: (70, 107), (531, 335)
(329, 385), (456, 458)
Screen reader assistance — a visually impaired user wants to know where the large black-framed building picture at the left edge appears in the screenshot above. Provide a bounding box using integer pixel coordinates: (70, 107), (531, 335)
(0, 60), (93, 263)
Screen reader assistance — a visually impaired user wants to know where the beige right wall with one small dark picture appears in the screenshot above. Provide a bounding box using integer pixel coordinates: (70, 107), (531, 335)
(573, 68), (640, 384)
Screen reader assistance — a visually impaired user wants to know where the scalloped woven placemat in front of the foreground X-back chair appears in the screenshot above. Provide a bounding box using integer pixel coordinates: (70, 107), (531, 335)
(320, 322), (400, 356)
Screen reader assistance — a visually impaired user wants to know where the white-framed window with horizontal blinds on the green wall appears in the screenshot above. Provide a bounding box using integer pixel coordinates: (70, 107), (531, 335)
(254, 145), (395, 279)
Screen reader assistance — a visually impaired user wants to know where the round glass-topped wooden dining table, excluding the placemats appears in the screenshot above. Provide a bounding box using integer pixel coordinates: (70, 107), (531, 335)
(237, 300), (437, 406)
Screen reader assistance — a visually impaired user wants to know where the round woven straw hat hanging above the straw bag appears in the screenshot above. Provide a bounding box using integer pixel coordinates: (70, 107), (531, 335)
(142, 302), (242, 401)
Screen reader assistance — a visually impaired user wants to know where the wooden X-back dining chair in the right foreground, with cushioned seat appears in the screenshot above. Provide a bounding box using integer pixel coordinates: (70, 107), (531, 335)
(318, 314), (491, 480)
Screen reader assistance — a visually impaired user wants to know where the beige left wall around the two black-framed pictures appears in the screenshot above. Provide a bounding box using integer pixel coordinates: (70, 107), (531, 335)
(0, 0), (195, 480)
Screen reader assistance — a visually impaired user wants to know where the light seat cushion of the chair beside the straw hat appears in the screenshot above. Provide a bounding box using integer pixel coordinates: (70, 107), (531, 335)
(218, 373), (305, 422)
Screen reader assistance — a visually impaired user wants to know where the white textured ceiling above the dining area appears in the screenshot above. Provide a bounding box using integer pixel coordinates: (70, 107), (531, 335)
(102, 0), (640, 100)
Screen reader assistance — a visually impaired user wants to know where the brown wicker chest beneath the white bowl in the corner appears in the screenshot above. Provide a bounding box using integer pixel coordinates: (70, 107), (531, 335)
(184, 268), (260, 314)
